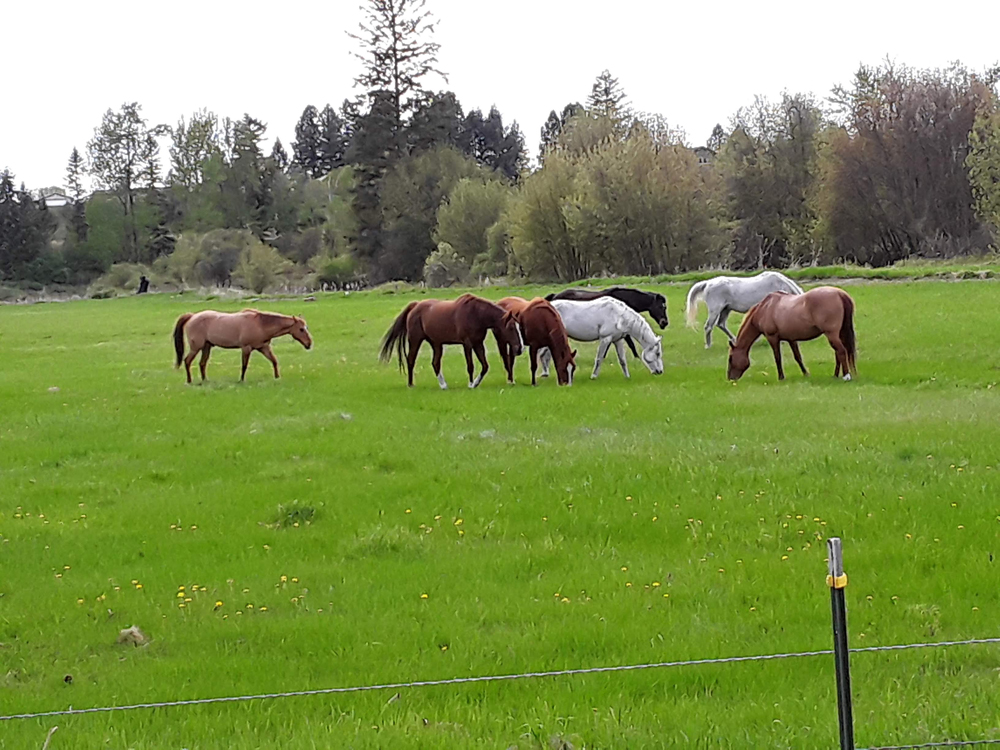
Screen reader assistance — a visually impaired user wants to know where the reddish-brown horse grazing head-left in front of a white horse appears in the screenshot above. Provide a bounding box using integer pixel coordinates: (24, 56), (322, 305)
(729, 286), (857, 380)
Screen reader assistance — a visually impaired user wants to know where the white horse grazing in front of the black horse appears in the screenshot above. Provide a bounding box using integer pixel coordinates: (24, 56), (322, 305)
(541, 297), (663, 378)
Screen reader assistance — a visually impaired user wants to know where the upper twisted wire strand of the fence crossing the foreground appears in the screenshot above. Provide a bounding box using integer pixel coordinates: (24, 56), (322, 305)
(0, 638), (1000, 724)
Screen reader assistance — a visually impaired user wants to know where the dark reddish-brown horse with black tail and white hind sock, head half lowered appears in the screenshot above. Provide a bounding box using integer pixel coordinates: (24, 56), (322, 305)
(379, 294), (524, 389)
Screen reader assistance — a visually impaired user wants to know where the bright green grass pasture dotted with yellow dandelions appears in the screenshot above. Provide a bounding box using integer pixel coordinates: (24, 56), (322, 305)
(0, 281), (1000, 750)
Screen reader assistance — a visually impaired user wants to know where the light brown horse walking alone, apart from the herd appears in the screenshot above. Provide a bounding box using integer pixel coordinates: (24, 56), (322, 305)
(174, 309), (312, 383)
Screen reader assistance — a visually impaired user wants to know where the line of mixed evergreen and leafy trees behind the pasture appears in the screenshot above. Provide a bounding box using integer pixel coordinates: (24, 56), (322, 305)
(0, 0), (1000, 292)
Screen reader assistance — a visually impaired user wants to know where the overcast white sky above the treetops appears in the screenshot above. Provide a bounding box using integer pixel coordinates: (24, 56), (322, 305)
(0, 0), (1000, 188)
